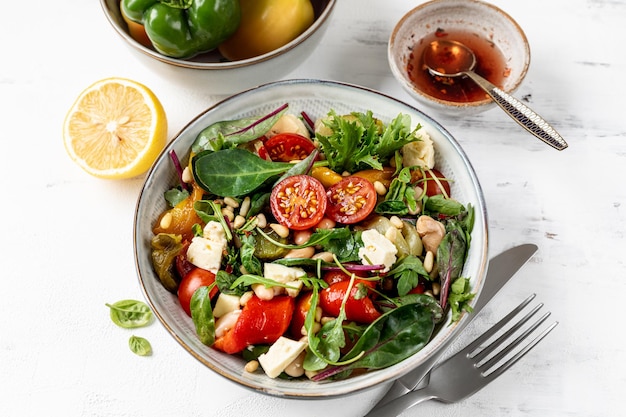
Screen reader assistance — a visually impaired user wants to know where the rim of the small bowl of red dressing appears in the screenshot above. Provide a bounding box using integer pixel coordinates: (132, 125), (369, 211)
(387, 0), (531, 109)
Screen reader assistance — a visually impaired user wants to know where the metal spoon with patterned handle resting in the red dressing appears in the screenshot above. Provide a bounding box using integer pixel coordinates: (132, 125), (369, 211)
(424, 40), (567, 150)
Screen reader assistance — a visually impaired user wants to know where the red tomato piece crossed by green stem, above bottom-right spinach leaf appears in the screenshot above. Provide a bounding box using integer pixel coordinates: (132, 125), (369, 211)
(320, 279), (381, 324)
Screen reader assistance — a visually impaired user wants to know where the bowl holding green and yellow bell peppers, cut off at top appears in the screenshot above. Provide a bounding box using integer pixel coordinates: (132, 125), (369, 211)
(100, 0), (336, 93)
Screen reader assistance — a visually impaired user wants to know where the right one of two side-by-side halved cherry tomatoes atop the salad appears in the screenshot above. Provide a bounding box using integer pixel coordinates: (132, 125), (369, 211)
(326, 177), (378, 224)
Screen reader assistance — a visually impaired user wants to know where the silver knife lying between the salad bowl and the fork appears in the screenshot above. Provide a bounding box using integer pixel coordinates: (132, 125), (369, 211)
(373, 243), (537, 410)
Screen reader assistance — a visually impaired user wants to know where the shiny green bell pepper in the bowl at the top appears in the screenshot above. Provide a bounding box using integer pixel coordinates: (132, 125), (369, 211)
(121, 0), (241, 58)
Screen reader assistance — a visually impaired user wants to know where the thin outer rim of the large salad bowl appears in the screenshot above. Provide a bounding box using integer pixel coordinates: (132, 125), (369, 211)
(133, 79), (489, 399)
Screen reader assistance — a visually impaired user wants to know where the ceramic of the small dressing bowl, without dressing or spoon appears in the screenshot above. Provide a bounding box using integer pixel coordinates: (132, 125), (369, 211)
(388, 0), (530, 116)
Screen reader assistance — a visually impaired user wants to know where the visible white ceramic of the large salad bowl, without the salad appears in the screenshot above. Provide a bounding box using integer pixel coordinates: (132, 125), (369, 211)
(134, 80), (488, 399)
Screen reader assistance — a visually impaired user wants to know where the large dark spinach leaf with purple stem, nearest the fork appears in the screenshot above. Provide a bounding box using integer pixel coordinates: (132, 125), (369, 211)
(313, 304), (435, 381)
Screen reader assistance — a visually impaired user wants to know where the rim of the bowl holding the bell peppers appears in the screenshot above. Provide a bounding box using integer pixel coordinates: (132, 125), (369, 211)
(100, 0), (337, 71)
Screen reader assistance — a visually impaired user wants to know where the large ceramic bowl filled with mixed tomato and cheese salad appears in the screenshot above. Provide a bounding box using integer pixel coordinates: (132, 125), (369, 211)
(134, 80), (488, 399)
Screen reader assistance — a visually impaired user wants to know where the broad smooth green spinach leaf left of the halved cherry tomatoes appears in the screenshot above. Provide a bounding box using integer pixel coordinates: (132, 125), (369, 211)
(193, 148), (293, 197)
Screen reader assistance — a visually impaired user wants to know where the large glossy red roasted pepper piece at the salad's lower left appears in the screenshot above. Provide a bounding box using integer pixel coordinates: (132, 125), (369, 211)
(213, 295), (295, 354)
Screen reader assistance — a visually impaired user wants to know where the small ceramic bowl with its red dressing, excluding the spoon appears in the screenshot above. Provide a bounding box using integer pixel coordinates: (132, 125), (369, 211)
(388, 0), (530, 116)
